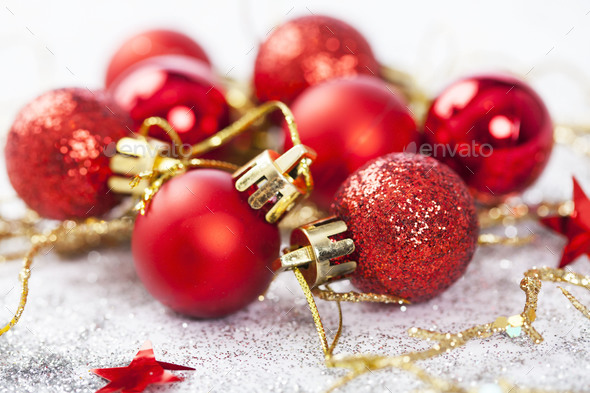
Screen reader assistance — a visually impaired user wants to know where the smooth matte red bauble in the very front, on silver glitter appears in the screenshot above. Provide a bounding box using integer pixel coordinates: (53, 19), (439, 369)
(132, 169), (280, 318)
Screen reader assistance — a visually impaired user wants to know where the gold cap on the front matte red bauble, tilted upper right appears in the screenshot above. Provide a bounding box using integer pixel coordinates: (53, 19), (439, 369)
(233, 144), (316, 224)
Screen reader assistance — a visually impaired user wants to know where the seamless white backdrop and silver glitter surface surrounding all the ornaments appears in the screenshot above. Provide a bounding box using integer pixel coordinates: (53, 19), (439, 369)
(0, 0), (590, 392)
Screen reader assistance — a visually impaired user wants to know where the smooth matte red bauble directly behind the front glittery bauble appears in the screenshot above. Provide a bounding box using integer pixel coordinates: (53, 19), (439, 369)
(287, 76), (420, 207)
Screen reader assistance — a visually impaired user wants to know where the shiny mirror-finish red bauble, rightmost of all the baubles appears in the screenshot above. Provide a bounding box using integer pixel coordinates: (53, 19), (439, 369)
(423, 75), (553, 202)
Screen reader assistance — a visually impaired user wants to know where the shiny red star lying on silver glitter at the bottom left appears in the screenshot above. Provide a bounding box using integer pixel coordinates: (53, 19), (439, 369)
(90, 340), (194, 393)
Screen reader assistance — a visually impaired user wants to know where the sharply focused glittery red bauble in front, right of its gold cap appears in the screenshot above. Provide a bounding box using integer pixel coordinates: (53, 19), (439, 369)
(332, 153), (478, 302)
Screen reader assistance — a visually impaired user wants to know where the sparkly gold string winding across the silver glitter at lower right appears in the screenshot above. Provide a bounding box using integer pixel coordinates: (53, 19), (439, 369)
(294, 268), (590, 392)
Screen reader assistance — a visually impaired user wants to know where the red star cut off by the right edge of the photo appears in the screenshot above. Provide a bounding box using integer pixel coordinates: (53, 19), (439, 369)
(541, 178), (590, 268)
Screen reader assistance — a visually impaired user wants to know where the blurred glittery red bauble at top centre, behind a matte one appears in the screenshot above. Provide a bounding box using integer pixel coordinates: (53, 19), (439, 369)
(254, 15), (379, 103)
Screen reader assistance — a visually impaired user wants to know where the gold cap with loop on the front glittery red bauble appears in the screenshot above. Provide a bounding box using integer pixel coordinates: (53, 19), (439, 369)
(273, 216), (357, 288)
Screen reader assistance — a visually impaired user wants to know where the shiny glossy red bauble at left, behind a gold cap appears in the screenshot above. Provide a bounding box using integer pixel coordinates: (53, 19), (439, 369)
(109, 55), (229, 145)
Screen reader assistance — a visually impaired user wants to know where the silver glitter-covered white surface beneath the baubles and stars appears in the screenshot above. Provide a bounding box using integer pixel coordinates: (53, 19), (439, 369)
(0, 148), (590, 392)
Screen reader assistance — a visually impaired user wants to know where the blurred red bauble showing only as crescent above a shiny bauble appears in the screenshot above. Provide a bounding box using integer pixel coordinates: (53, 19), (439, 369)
(105, 30), (210, 87)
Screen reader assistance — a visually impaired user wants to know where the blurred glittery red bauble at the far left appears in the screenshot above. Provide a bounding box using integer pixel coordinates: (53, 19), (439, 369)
(5, 88), (131, 220)
